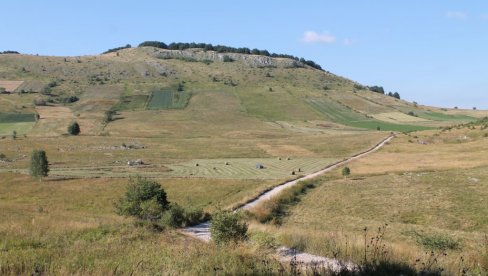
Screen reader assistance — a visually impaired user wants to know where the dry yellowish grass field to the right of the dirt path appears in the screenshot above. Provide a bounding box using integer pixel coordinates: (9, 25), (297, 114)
(251, 133), (488, 274)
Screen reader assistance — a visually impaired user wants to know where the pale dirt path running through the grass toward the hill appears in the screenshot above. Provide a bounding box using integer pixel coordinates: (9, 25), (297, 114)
(183, 134), (395, 270)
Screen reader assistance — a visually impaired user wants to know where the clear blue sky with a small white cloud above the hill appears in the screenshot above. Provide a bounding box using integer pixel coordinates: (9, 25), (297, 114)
(0, 0), (488, 109)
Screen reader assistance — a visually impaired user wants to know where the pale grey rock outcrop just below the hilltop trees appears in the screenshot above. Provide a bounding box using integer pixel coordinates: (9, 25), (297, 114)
(153, 49), (305, 68)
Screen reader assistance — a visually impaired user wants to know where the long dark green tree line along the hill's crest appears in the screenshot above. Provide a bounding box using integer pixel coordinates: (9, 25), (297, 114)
(138, 41), (324, 71)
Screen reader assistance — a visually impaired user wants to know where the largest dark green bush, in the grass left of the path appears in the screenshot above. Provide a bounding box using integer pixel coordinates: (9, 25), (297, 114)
(115, 177), (169, 221)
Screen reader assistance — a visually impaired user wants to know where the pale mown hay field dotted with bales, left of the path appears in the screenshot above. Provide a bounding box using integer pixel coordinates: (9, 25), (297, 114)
(167, 158), (338, 179)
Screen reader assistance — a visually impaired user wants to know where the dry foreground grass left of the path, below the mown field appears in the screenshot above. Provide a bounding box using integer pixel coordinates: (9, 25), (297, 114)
(0, 173), (288, 275)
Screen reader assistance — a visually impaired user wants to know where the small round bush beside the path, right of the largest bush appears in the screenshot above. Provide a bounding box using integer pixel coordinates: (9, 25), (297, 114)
(210, 211), (247, 244)
